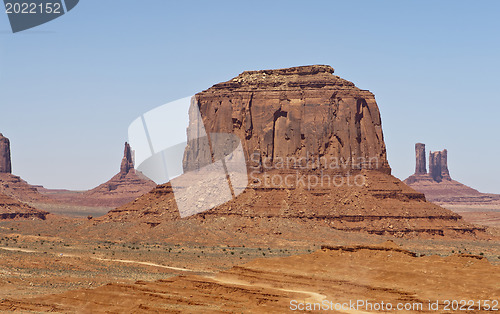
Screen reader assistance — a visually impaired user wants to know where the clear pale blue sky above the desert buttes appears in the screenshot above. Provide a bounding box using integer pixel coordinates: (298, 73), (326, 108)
(0, 0), (500, 193)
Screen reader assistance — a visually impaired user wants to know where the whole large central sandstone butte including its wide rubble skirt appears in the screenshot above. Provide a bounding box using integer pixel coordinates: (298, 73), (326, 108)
(101, 65), (486, 237)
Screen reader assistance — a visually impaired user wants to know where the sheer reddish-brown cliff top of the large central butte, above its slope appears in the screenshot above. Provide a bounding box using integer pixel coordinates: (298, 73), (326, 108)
(184, 65), (391, 173)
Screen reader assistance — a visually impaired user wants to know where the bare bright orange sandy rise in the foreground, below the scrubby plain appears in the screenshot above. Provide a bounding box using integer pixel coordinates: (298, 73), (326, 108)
(0, 243), (500, 313)
